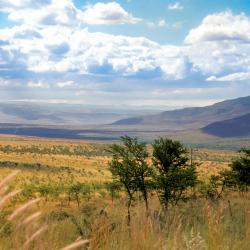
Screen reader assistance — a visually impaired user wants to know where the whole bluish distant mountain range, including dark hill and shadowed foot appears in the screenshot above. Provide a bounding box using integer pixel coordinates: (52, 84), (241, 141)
(0, 96), (250, 139)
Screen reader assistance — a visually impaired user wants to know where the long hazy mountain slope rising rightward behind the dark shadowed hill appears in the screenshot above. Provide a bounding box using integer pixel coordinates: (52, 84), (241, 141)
(113, 96), (250, 130)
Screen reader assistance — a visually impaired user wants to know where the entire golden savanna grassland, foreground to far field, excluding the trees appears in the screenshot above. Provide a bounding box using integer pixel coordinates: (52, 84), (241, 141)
(0, 136), (250, 250)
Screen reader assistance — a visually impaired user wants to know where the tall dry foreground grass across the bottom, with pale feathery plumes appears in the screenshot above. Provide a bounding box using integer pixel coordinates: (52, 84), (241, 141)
(0, 173), (250, 250)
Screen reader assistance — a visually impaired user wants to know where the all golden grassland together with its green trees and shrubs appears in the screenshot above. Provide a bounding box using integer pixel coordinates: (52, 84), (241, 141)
(0, 136), (250, 250)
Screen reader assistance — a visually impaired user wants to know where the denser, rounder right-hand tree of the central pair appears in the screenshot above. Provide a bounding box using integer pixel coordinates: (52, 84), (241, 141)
(152, 138), (197, 209)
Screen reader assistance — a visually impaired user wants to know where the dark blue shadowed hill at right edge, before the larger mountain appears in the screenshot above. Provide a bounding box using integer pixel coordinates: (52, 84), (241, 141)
(202, 113), (250, 137)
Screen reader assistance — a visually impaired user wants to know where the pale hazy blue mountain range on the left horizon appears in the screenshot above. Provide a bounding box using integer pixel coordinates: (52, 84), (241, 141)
(0, 101), (159, 126)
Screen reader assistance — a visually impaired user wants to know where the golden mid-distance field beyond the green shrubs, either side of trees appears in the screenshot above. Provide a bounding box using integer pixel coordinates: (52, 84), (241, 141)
(0, 136), (237, 186)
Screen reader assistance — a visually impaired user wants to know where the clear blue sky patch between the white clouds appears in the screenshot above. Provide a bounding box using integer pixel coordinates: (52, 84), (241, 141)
(75, 0), (250, 44)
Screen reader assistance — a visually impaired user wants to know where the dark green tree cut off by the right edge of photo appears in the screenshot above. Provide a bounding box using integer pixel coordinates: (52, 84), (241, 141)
(231, 148), (250, 191)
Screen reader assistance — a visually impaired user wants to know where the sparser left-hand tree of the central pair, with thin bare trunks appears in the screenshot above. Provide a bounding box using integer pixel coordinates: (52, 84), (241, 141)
(109, 136), (152, 221)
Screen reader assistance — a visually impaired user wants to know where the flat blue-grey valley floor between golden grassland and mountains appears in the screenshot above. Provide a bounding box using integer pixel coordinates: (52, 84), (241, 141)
(0, 124), (250, 150)
